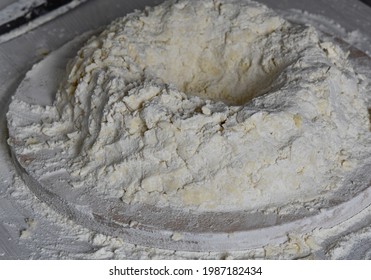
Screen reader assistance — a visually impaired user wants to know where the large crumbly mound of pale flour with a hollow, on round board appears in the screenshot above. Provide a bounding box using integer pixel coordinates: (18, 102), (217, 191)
(8, 0), (370, 257)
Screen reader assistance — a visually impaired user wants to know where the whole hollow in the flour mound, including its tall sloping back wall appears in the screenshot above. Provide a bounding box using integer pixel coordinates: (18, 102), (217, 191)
(132, 9), (292, 105)
